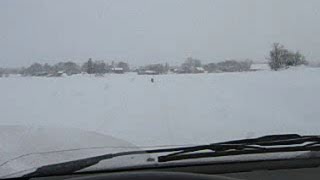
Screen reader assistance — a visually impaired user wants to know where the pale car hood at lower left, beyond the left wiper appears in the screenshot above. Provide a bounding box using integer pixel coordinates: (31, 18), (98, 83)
(0, 126), (148, 178)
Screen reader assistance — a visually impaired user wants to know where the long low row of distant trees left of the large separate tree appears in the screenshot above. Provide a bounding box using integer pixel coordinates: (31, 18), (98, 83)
(0, 57), (252, 77)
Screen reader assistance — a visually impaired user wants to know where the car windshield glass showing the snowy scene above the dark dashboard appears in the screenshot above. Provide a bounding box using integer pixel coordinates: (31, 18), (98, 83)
(0, 0), (320, 177)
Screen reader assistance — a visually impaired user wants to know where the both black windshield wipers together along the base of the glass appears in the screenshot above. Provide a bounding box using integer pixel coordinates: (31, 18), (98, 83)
(23, 134), (320, 178)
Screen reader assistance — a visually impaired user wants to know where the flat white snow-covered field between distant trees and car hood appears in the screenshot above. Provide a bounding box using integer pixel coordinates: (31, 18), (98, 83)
(0, 68), (320, 146)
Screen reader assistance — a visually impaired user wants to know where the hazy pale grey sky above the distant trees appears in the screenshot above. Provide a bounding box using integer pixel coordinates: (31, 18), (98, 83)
(0, 0), (320, 66)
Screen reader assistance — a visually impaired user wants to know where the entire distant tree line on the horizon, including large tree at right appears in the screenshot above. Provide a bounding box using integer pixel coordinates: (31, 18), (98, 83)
(0, 43), (308, 77)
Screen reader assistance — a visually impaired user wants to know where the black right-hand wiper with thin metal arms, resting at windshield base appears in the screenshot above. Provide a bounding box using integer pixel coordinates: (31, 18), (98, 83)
(158, 134), (320, 162)
